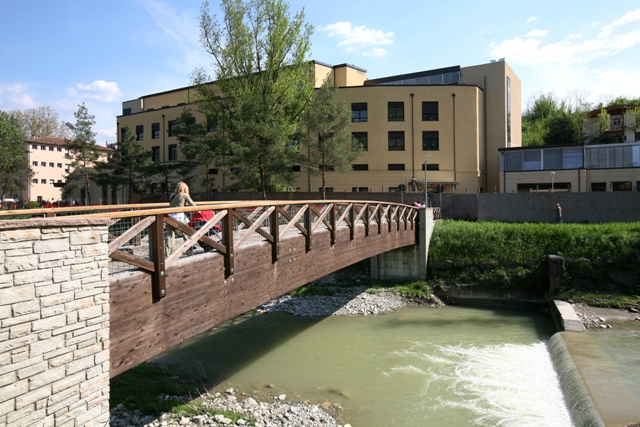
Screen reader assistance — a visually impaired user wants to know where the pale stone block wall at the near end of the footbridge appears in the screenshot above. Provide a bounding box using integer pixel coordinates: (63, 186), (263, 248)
(0, 217), (109, 427)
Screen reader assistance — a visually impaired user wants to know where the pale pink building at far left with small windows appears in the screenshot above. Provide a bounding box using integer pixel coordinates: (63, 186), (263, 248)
(18, 136), (117, 204)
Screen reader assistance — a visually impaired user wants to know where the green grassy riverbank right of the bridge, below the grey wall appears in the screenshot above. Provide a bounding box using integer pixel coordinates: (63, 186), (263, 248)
(429, 220), (640, 308)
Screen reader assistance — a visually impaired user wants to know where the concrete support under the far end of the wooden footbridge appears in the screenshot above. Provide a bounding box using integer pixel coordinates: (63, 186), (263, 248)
(371, 208), (435, 280)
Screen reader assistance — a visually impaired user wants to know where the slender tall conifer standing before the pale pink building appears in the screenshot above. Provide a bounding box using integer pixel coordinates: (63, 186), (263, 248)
(63, 103), (100, 205)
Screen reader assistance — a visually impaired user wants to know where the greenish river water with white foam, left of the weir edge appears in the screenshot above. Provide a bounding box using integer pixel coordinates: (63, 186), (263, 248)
(156, 307), (573, 427)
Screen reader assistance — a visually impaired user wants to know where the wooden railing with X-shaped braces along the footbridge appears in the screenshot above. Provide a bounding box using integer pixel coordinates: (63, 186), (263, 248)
(32, 200), (417, 301)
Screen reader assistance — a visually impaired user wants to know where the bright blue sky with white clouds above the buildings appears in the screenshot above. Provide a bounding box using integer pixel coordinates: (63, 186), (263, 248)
(0, 0), (640, 144)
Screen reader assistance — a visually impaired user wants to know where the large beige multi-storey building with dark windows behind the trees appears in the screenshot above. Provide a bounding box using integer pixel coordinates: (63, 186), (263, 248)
(117, 61), (521, 196)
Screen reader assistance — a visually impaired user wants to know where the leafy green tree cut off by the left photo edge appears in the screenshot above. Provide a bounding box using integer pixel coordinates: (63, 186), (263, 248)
(0, 111), (33, 209)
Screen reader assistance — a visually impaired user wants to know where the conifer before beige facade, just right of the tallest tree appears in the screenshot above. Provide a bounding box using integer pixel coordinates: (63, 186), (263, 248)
(303, 77), (364, 198)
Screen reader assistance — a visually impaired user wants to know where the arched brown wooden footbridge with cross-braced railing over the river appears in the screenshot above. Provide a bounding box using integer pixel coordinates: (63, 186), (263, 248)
(0, 200), (419, 377)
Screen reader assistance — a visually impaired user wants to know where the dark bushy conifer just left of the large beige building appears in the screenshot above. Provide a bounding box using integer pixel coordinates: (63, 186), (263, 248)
(94, 126), (151, 203)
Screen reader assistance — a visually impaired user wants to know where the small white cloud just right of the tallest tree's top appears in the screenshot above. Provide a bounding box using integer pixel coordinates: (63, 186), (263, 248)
(318, 22), (395, 57)
